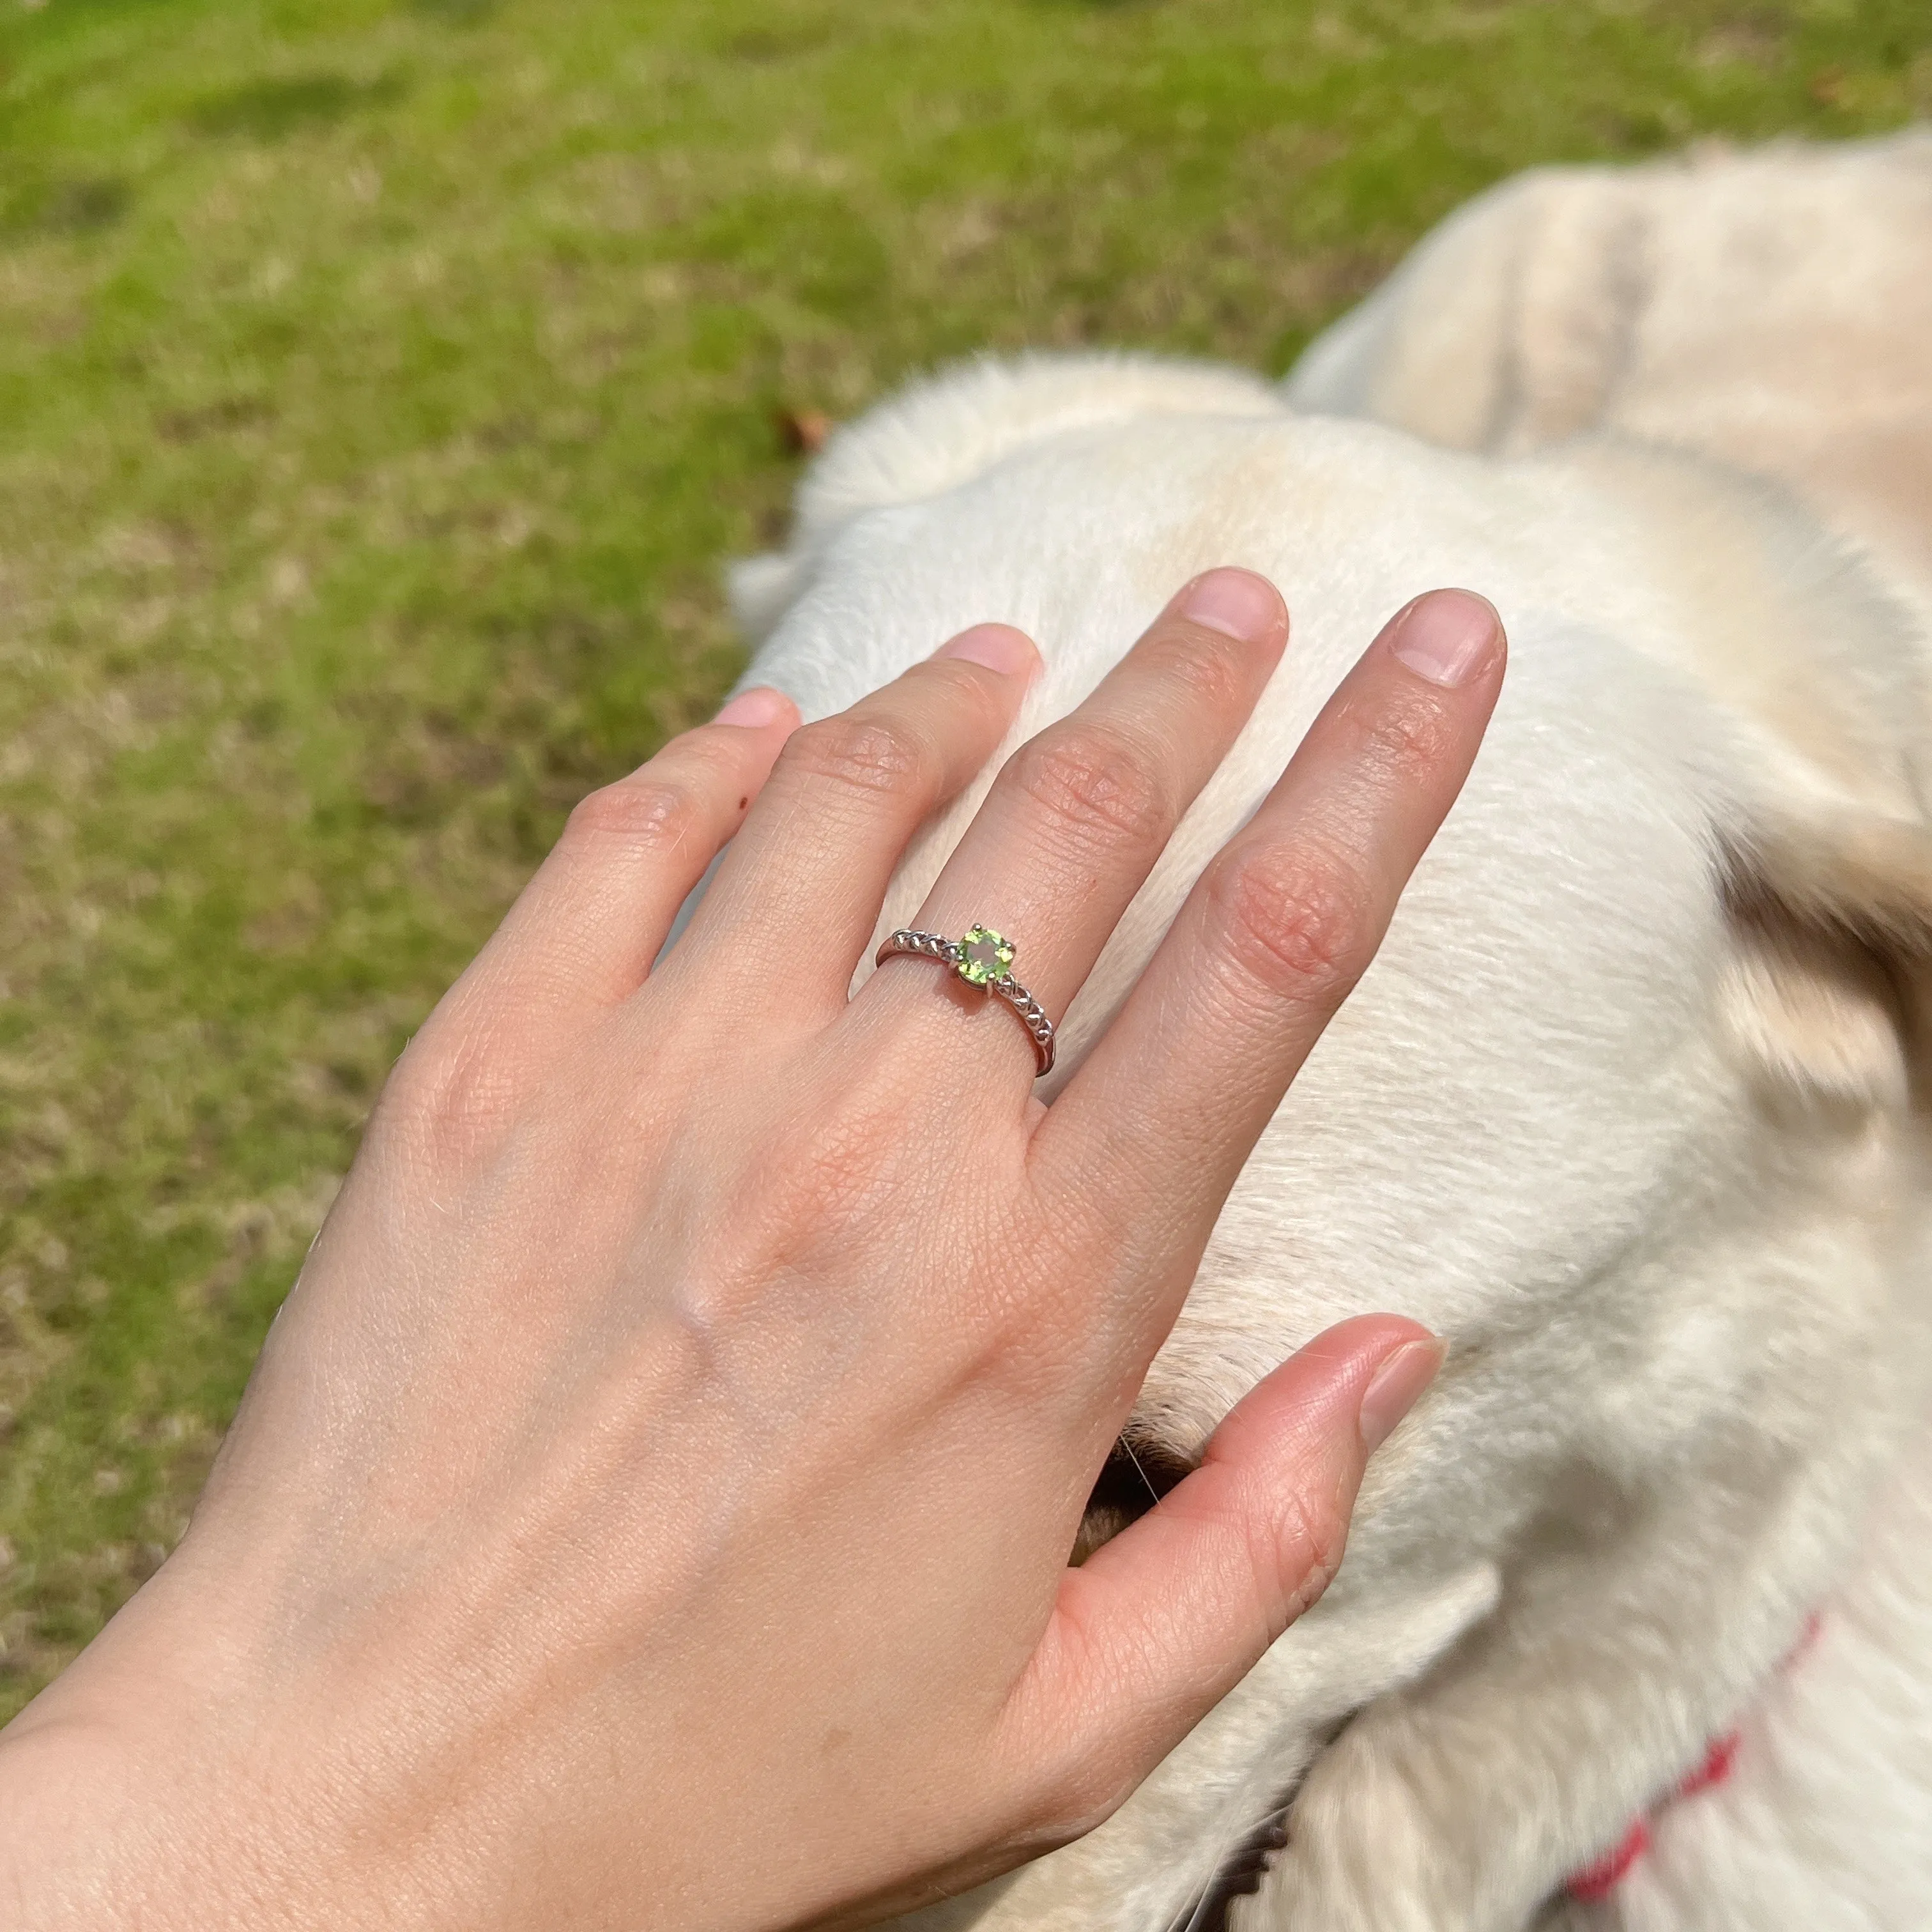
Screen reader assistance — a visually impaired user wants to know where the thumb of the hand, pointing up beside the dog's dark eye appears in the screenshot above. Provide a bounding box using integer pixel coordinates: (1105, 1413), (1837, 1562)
(1015, 1315), (1443, 1824)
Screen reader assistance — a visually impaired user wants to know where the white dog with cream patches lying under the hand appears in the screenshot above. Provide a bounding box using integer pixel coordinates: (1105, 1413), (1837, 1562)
(718, 137), (1932, 1932)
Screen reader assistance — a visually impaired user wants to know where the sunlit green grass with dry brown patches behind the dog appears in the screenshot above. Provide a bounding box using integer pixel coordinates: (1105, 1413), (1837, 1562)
(0, 0), (1932, 1717)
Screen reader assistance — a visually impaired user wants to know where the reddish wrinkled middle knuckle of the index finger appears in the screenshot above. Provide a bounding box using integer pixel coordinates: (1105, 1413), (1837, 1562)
(1208, 844), (1374, 1002)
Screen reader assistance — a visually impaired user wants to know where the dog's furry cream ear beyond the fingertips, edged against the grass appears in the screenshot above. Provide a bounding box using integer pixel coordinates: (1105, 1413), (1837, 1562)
(726, 353), (1287, 643)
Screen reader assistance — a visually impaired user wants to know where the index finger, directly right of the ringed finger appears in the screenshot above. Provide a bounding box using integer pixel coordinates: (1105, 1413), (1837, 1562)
(1032, 591), (1507, 1291)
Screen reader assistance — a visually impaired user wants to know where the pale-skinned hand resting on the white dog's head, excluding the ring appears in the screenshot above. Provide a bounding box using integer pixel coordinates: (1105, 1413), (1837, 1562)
(0, 570), (1505, 1932)
